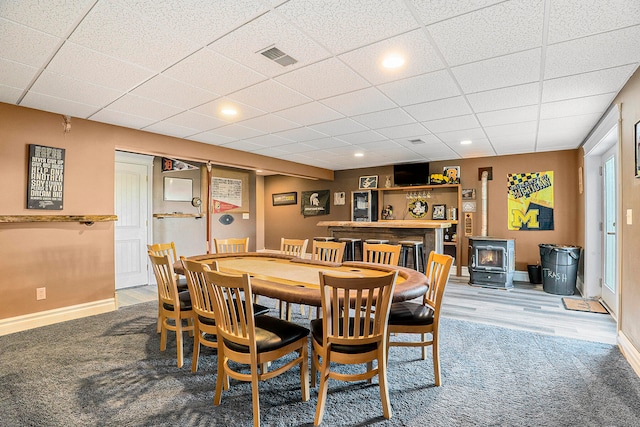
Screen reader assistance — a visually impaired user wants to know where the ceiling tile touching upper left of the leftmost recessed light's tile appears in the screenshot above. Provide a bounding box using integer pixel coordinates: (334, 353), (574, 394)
(131, 75), (218, 109)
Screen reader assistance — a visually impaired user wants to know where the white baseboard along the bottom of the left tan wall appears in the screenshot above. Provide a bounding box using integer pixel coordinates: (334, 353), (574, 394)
(0, 298), (118, 336)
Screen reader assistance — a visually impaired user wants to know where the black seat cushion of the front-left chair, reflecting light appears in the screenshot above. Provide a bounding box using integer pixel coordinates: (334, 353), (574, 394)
(224, 315), (309, 353)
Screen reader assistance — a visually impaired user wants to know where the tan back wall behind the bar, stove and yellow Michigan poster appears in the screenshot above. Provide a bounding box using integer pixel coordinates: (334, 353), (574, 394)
(265, 150), (581, 271)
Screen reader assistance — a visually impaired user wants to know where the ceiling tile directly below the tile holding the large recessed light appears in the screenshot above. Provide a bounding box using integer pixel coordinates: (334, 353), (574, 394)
(378, 71), (460, 105)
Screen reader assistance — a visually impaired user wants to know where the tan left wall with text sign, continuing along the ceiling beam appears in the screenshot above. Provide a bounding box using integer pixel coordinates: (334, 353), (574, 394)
(0, 103), (333, 319)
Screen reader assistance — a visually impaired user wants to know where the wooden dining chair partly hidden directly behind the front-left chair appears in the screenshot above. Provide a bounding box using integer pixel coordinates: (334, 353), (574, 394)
(182, 258), (269, 372)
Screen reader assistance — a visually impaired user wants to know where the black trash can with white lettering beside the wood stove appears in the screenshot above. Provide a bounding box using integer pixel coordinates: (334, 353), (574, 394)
(539, 243), (582, 295)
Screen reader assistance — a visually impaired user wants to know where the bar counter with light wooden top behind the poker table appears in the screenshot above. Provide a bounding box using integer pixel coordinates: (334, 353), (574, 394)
(317, 220), (451, 254)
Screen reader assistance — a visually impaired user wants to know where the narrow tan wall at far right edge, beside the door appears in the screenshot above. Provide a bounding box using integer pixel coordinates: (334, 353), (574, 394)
(614, 70), (640, 351)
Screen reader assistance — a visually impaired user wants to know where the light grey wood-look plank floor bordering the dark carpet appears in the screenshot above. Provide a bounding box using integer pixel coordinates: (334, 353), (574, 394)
(116, 275), (617, 344)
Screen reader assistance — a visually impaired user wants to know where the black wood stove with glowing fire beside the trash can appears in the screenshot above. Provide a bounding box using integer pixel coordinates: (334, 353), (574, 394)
(469, 236), (516, 289)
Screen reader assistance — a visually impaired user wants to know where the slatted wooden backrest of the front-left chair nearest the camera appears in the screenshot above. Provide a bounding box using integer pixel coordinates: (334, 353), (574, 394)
(204, 271), (256, 354)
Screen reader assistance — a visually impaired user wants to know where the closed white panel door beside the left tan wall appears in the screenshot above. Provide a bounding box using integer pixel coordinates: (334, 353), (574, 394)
(115, 153), (152, 289)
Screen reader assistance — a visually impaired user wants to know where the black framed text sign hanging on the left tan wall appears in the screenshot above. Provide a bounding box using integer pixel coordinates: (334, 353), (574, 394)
(27, 144), (65, 210)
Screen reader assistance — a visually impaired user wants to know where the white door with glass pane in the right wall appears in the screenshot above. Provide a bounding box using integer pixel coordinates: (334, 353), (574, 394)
(602, 146), (618, 317)
